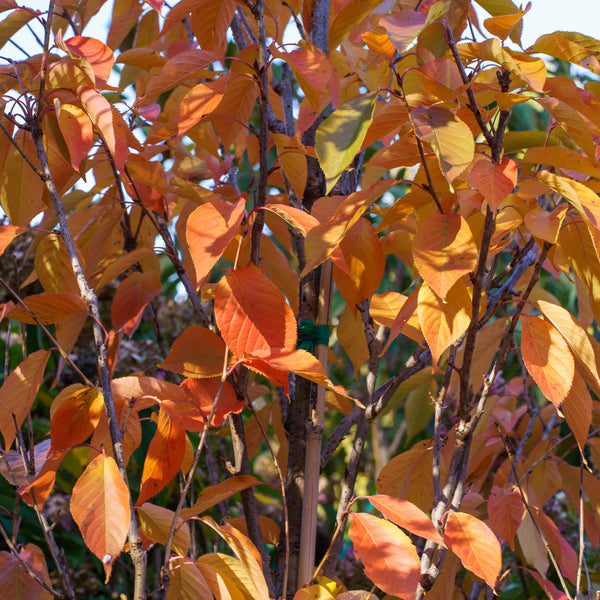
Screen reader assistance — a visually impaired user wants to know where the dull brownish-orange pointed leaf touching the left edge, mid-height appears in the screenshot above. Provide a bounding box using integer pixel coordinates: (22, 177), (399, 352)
(0, 350), (50, 451)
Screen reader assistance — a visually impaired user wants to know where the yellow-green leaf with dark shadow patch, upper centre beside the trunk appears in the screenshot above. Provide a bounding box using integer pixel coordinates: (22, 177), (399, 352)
(315, 95), (377, 193)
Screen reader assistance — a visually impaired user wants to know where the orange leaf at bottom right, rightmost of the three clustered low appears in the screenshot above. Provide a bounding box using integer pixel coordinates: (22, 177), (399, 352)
(444, 512), (502, 588)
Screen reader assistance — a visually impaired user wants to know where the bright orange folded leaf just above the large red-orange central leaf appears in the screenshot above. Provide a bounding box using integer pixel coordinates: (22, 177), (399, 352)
(185, 198), (245, 287)
